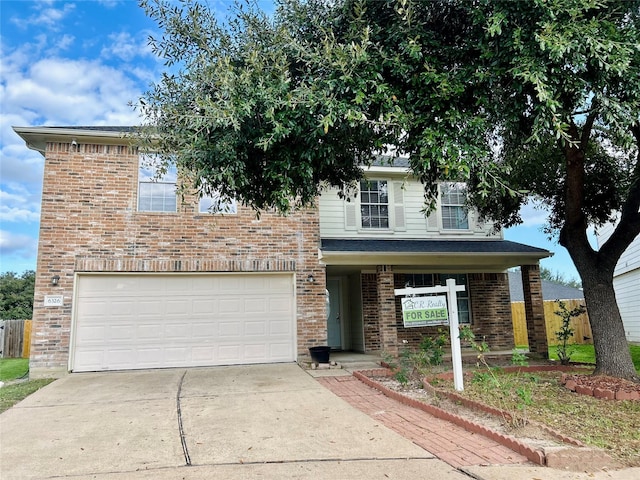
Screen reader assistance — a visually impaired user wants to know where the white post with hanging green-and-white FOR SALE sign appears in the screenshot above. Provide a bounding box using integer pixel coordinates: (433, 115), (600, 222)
(395, 278), (465, 392)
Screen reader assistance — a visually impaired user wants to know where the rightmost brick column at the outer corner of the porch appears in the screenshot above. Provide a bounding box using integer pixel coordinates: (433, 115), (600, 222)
(521, 265), (549, 358)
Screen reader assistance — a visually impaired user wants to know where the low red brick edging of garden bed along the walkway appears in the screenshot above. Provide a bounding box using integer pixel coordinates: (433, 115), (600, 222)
(353, 368), (613, 468)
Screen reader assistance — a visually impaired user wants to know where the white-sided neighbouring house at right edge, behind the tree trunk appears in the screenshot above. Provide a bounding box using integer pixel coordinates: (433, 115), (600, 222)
(596, 223), (640, 342)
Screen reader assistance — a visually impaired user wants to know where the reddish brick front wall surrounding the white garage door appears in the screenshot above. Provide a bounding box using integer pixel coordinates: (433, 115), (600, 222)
(31, 140), (327, 372)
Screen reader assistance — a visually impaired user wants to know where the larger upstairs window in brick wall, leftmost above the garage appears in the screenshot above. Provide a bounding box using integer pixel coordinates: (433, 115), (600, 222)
(138, 155), (178, 212)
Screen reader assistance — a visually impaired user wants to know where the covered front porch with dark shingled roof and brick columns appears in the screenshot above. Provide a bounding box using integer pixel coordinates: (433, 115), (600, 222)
(321, 239), (551, 356)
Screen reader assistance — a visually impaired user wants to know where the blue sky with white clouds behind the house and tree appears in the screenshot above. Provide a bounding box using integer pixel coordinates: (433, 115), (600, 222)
(0, 0), (578, 278)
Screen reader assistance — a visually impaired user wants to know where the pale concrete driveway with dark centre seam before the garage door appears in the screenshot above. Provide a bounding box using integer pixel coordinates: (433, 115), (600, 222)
(0, 364), (469, 480)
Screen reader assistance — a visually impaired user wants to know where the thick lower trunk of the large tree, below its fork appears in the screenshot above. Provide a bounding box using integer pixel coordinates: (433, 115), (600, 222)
(578, 259), (640, 381)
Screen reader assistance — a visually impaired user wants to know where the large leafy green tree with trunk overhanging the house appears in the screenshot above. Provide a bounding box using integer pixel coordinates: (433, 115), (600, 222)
(140, 0), (640, 379)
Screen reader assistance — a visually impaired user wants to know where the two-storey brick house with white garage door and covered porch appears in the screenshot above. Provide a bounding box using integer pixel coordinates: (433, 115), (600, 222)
(14, 127), (550, 376)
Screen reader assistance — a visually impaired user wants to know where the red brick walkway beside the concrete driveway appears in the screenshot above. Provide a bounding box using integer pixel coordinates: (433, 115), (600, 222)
(317, 375), (528, 468)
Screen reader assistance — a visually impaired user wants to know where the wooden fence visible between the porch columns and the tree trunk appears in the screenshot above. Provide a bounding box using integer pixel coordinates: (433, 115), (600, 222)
(511, 300), (593, 346)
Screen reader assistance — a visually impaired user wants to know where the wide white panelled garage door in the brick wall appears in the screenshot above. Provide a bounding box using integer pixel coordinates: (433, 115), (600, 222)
(71, 274), (295, 372)
